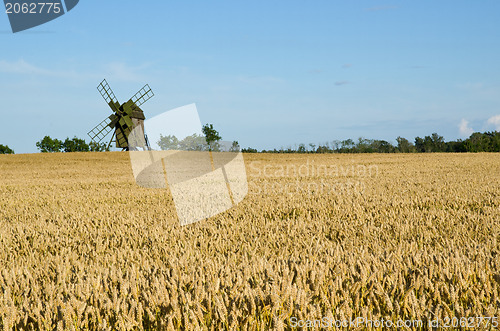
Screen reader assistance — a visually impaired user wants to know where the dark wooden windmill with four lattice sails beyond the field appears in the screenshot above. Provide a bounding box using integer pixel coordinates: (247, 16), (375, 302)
(87, 79), (154, 151)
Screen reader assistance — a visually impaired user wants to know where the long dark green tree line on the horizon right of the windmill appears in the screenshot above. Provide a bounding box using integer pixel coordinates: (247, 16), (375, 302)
(242, 131), (500, 153)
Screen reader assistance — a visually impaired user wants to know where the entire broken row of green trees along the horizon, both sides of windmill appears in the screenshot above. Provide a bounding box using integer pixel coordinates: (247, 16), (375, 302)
(0, 130), (500, 154)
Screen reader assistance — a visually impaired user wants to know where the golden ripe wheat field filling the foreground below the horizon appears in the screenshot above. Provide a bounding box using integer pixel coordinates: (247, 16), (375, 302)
(0, 152), (500, 330)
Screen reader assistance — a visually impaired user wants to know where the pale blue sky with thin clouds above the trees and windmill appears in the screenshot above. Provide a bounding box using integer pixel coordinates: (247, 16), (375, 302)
(0, 0), (500, 153)
